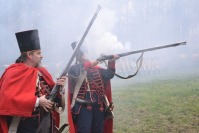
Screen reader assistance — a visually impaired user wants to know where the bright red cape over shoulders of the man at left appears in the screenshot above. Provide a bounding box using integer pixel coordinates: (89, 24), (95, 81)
(0, 63), (59, 133)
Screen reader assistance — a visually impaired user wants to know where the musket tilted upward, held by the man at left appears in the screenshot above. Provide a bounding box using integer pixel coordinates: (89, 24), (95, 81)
(36, 5), (101, 133)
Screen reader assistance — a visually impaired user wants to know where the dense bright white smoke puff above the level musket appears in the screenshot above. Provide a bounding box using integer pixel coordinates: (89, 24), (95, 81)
(86, 7), (130, 58)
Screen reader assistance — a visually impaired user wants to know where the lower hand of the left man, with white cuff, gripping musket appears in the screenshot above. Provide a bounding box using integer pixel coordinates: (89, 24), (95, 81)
(39, 95), (54, 112)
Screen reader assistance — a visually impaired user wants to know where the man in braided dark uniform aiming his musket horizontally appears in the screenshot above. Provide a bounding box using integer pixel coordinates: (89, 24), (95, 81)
(68, 44), (119, 133)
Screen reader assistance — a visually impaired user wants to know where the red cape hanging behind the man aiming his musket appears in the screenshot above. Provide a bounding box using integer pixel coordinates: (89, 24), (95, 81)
(67, 67), (113, 133)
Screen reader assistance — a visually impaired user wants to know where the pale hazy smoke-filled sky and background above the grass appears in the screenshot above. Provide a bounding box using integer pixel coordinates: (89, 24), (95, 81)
(0, 0), (199, 77)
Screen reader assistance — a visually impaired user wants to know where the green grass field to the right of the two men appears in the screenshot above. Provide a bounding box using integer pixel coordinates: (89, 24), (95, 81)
(61, 73), (199, 133)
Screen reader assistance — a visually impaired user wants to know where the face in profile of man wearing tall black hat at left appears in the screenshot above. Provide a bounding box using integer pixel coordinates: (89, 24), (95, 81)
(29, 50), (43, 67)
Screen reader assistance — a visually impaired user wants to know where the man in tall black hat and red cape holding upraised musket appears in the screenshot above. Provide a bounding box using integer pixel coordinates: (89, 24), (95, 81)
(0, 30), (66, 133)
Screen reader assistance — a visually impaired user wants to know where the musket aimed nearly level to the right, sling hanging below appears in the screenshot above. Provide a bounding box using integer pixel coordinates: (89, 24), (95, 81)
(97, 42), (186, 62)
